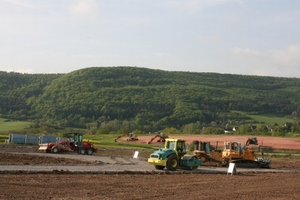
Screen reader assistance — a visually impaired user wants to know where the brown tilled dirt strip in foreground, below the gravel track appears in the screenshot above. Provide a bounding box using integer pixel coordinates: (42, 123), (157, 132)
(0, 173), (300, 200)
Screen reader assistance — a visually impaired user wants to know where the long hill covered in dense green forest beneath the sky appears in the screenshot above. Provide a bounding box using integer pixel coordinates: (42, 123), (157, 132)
(0, 67), (300, 129)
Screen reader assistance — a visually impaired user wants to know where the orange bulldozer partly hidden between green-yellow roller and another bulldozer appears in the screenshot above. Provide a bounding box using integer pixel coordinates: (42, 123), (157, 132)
(193, 140), (223, 166)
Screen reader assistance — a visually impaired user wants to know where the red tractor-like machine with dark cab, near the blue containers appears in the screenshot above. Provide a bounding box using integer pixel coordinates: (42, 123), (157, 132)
(39, 133), (98, 155)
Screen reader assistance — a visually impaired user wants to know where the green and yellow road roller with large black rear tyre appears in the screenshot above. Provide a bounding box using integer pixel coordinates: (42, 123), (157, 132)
(148, 139), (202, 171)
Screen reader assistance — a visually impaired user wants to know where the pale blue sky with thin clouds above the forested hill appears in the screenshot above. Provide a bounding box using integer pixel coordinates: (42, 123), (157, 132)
(0, 0), (300, 78)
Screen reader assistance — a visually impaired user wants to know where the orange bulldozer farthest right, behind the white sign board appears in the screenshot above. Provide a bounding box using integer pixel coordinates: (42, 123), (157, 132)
(222, 141), (271, 168)
